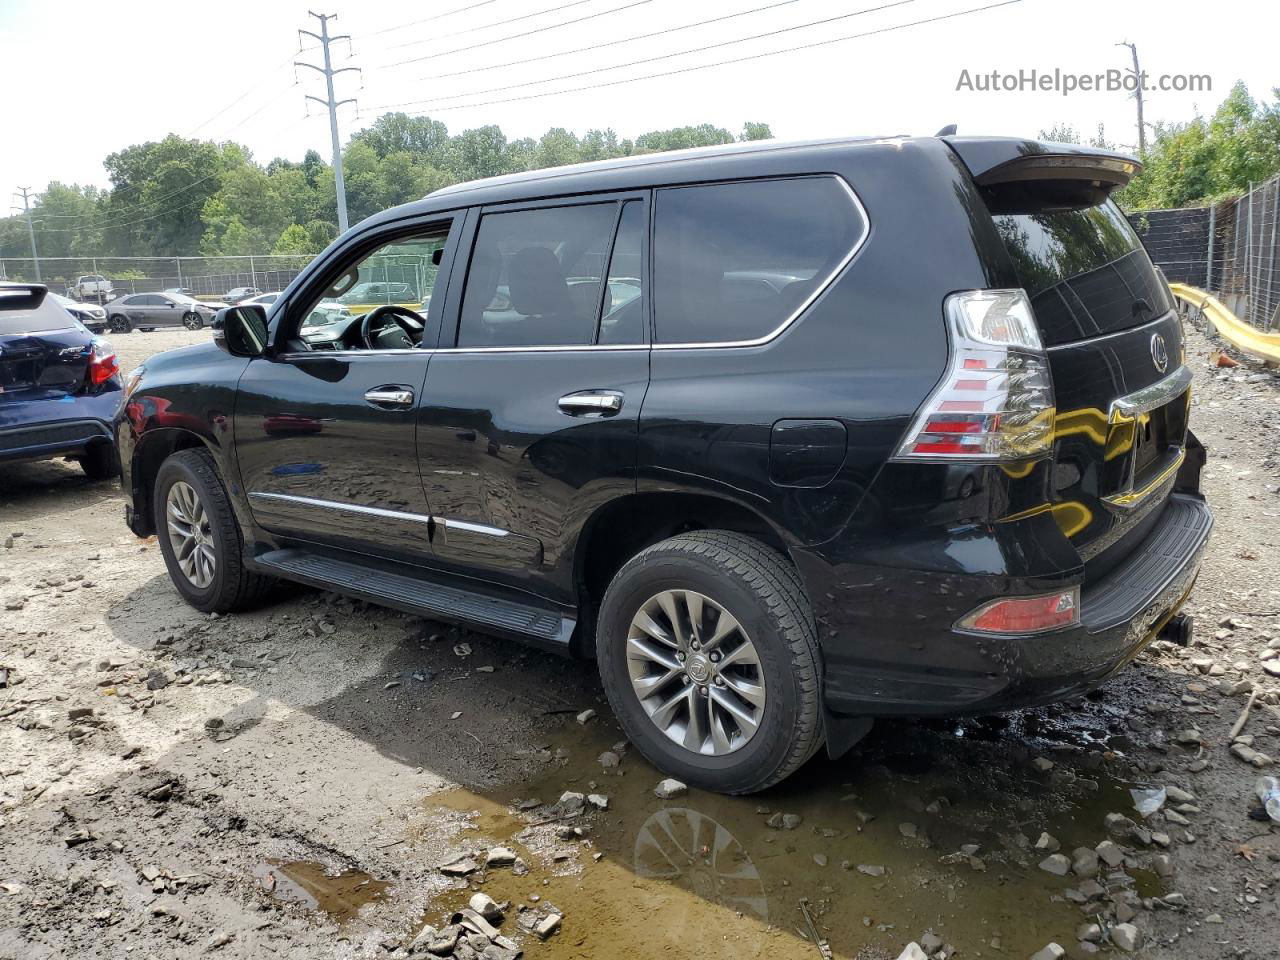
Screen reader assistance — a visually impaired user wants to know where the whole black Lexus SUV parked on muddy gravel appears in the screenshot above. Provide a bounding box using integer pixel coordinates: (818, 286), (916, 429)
(118, 137), (1212, 792)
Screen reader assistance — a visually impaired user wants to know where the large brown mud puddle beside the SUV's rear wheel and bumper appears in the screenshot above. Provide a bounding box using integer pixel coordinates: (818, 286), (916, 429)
(414, 716), (1162, 960)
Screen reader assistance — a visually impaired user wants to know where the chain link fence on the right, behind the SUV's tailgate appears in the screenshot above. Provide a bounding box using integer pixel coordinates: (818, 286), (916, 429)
(1129, 177), (1280, 330)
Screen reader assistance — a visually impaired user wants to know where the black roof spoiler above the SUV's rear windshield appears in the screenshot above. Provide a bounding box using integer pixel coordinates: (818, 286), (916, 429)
(943, 137), (1142, 193)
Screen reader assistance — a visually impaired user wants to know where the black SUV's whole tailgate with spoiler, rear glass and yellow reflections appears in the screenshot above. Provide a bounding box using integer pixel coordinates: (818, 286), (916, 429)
(952, 140), (1190, 580)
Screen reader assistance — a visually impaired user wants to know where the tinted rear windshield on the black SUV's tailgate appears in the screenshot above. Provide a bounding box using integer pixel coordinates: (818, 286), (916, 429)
(992, 200), (1172, 346)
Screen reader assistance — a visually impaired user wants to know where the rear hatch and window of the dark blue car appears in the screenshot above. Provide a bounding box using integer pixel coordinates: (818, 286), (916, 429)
(0, 287), (93, 404)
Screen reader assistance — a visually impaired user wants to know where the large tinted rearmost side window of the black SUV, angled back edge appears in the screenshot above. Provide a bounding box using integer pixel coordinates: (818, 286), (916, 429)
(654, 177), (865, 343)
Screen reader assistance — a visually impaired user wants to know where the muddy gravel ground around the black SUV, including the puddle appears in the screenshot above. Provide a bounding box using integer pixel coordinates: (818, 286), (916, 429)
(0, 323), (1280, 960)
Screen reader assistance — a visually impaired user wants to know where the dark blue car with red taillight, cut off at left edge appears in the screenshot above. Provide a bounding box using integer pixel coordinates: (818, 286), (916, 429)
(0, 283), (124, 480)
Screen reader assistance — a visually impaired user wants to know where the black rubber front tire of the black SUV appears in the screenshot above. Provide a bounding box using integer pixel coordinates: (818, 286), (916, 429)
(151, 449), (275, 613)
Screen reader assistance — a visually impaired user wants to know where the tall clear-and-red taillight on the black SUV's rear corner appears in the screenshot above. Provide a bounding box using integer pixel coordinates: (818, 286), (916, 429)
(897, 289), (1053, 461)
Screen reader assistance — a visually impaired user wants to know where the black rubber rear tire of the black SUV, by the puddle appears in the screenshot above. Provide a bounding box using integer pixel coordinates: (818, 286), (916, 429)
(596, 530), (822, 794)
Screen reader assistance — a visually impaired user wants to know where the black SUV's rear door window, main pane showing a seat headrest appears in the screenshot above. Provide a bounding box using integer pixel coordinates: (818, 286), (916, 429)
(458, 202), (618, 347)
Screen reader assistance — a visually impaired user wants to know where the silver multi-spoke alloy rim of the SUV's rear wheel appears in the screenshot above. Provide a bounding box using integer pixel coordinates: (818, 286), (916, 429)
(627, 590), (765, 756)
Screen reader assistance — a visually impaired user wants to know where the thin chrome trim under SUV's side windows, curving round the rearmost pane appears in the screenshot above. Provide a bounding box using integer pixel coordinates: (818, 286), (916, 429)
(278, 173), (865, 360)
